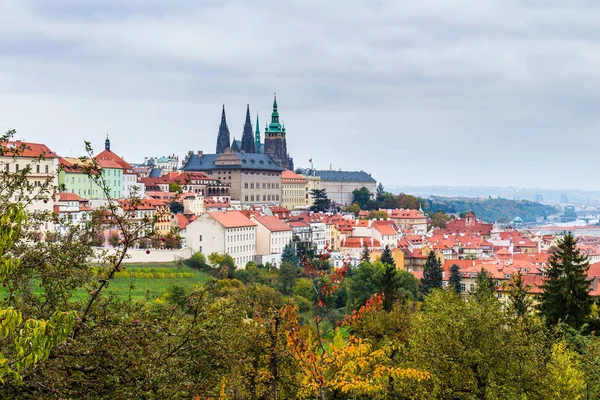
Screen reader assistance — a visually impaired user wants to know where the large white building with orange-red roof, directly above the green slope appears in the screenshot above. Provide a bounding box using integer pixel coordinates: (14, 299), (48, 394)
(186, 211), (256, 267)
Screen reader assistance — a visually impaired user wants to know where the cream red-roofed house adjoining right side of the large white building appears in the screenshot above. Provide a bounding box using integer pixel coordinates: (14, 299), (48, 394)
(251, 215), (292, 266)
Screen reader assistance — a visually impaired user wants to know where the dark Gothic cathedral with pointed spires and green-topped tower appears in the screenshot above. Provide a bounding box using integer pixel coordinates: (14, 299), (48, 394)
(216, 93), (294, 171)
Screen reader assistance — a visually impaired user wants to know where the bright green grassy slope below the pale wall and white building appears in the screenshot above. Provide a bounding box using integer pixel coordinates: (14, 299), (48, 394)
(72, 262), (209, 301)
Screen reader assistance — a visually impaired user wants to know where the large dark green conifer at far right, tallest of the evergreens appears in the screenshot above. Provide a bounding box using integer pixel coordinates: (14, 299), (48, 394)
(539, 233), (592, 329)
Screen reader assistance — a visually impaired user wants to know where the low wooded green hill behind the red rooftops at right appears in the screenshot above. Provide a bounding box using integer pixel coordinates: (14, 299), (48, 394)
(424, 196), (559, 223)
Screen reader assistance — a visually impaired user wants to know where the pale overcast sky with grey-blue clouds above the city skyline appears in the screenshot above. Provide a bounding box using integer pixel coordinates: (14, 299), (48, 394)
(0, 0), (600, 190)
